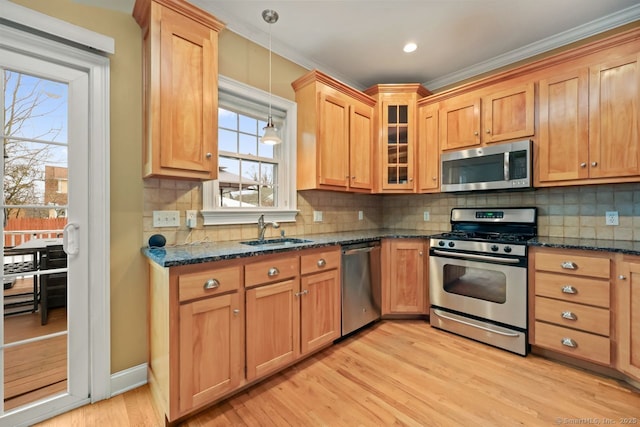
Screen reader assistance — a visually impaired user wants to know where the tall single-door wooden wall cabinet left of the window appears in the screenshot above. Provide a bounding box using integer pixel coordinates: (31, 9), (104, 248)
(133, 0), (223, 180)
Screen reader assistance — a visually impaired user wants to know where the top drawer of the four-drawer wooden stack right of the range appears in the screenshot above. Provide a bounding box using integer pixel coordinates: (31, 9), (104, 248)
(535, 252), (611, 279)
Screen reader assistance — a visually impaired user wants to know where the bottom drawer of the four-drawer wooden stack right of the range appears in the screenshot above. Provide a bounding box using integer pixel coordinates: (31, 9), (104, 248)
(535, 322), (611, 365)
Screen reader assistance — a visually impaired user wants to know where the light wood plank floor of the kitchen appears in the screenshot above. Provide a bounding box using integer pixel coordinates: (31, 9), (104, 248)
(39, 321), (640, 427)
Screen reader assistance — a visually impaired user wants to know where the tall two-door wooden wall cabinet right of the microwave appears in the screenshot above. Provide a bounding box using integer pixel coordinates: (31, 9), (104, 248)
(536, 54), (640, 185)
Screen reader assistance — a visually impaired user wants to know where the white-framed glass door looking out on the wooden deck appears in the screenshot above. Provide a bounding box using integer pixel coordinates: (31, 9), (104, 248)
(0, 44), (89, 424)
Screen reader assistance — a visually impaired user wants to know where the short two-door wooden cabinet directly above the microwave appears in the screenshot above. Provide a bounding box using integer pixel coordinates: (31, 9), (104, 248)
(440, 83), (535, 150)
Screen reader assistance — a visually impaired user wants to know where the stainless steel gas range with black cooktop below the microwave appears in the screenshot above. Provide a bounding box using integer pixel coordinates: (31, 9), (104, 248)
(429, 207), (537, 356)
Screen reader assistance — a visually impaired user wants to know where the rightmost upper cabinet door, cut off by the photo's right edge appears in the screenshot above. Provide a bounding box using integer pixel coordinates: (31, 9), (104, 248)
(589, 54), (640, 178)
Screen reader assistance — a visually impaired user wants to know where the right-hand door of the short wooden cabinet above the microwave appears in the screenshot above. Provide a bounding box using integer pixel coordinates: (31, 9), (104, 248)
(481, 83), (535, 143)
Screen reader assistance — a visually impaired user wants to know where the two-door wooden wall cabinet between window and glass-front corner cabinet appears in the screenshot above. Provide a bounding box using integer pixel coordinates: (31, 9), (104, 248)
(291, 70), (375, 193)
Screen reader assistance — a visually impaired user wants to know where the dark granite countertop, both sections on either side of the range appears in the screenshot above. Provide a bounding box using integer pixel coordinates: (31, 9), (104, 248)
(142, 229), (640, 267)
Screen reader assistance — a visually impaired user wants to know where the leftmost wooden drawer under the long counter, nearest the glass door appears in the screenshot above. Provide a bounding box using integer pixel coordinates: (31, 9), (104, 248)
(178, 266), (242, 302)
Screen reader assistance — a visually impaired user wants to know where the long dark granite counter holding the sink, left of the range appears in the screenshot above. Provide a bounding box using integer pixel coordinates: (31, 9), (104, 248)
(142, 230), (441, 267)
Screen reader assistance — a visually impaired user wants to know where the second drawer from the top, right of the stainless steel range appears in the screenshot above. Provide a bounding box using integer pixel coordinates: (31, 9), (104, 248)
(534, 271), (609, 308)
